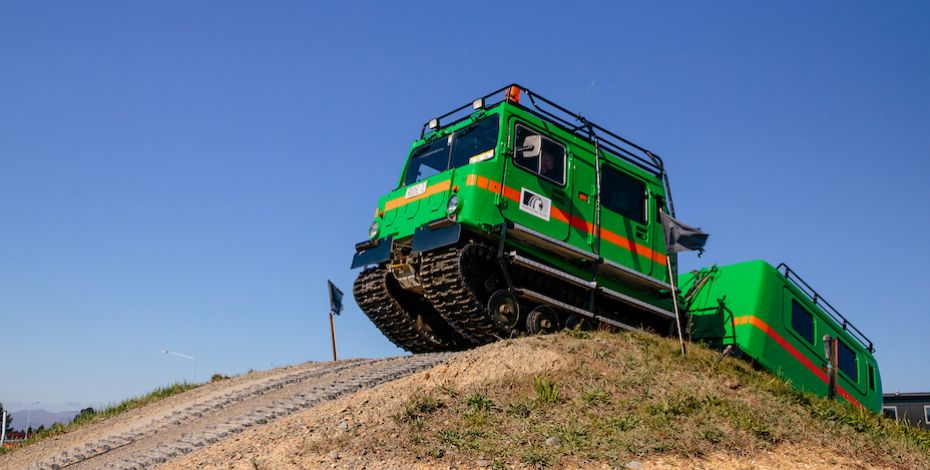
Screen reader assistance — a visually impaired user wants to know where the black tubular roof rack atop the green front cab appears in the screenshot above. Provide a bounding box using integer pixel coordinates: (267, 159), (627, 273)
(420, 83), (675, 217)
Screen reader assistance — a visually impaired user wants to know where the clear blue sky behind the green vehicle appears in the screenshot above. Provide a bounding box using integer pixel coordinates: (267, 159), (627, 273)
(0, 1), (930, 409)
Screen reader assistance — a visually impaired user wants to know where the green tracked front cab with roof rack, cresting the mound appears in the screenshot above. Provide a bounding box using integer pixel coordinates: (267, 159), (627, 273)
(352, 84), (675, 353)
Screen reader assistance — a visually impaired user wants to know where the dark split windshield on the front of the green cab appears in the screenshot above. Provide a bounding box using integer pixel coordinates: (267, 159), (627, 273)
(403, 116), (500, 186)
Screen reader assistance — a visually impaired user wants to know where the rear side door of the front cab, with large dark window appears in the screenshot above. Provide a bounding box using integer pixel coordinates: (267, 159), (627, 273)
(600, 161), (661, 275)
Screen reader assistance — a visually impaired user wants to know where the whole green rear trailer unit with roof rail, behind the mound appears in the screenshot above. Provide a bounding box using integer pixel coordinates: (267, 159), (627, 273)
(678, 260), (882, 411)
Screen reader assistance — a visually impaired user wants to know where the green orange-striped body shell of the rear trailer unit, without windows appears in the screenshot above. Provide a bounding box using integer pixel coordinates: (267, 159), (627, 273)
(679, 261), (882, 411)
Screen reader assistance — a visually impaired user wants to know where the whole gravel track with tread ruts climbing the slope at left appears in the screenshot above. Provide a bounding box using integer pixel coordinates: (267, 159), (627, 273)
(0, 354), (449, 470)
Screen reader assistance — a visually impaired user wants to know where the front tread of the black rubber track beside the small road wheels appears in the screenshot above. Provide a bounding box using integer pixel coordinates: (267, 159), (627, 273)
(420, 242), (510, 346)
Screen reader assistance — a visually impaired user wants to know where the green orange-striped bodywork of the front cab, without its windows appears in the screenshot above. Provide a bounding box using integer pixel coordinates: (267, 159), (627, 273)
(375, 101), (670, 298)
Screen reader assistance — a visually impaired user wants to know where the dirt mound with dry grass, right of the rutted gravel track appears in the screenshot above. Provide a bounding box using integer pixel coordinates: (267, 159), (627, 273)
(163, 333), (930, 469)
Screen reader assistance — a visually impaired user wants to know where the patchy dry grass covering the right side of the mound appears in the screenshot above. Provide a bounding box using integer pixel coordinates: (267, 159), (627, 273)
(363, 333), (930, 468)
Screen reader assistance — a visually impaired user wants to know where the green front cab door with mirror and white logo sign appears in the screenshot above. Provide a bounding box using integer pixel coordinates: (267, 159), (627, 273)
(504, 120), (572, 241)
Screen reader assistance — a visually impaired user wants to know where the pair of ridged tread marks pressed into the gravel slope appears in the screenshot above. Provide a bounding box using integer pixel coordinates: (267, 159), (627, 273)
(29, 354), (451, 470)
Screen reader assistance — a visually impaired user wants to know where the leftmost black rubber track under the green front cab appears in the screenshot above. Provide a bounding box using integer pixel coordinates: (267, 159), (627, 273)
(352, 267), (458, 353)
